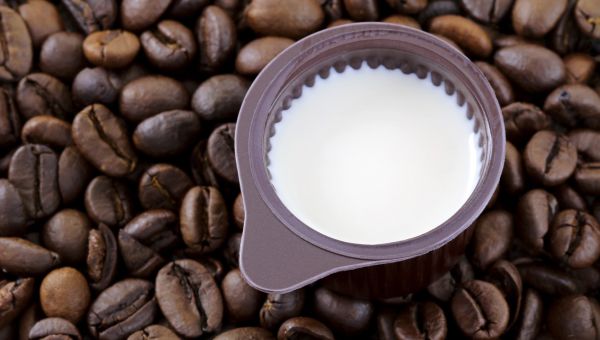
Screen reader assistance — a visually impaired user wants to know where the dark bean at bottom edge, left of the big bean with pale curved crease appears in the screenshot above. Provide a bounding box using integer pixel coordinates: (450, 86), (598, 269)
(87, 279), (157, 339)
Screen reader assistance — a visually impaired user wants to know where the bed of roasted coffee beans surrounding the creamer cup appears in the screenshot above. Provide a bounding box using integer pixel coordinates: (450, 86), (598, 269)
(0, 0), (600, 340)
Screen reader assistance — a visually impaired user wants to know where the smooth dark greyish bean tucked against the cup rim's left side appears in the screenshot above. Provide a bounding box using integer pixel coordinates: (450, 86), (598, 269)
(192, 74), (250, 121)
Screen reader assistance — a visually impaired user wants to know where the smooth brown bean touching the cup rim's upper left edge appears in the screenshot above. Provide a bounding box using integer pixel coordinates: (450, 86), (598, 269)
(235, 37), (294, 75)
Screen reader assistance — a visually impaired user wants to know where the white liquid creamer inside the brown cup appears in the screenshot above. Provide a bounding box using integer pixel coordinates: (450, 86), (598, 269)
(268, 65), (481, 244)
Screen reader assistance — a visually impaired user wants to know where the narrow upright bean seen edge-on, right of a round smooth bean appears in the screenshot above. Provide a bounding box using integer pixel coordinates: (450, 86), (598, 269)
(86, 224), (117, 290)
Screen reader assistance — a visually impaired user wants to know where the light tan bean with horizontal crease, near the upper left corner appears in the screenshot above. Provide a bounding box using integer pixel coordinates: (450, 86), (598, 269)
(83, 30), (140, 69)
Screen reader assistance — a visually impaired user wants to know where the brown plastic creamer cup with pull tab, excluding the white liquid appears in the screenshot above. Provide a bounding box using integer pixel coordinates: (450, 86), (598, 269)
(235, 23), (505, 299)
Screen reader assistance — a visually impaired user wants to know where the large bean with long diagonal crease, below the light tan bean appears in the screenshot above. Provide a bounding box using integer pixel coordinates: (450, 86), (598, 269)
(71, 104), (137, 177)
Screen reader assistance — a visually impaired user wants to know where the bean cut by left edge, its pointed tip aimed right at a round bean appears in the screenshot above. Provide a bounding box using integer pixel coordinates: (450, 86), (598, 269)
(0, 237), (60, 276)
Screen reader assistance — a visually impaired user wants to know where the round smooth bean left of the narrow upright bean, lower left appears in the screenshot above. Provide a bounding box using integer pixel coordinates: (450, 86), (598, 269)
(42, 209), (92, 265)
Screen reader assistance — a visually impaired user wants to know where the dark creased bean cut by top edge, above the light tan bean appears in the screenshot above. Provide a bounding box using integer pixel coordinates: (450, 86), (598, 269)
(61, 0), (117, 34)
